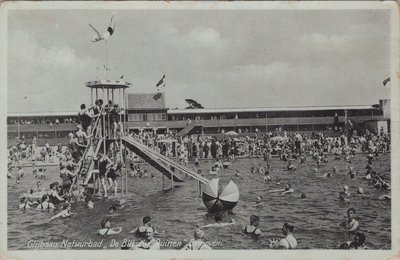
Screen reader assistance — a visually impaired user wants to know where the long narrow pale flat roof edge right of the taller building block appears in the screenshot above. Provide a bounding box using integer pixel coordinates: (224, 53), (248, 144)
(168, 105), (378, 114)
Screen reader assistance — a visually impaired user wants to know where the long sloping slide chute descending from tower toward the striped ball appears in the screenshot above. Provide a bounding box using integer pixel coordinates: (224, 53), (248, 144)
(121, 136), (209, 183)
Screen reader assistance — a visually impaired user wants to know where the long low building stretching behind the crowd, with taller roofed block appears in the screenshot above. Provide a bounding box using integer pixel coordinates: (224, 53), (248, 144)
(7, 93), (390, 145)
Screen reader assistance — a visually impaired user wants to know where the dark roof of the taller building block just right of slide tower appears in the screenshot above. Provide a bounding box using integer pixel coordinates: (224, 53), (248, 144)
(127, 92), (167, 110)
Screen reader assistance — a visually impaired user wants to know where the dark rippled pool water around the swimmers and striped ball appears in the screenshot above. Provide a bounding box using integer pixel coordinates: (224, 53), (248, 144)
(8, 154), (391, 250)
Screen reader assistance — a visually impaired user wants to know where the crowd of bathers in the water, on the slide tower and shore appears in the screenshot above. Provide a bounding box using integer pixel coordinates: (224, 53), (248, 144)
(8, 104), (391, 250)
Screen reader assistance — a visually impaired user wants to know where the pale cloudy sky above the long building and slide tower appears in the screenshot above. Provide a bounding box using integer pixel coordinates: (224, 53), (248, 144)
(7, 9), (390, 112)
